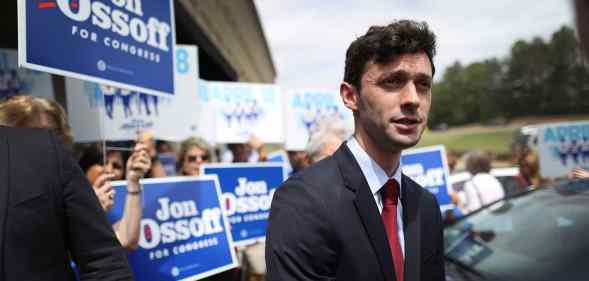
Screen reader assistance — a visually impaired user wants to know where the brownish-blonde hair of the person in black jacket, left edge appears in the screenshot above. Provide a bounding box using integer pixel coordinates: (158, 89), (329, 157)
(0, 96), (73, 146)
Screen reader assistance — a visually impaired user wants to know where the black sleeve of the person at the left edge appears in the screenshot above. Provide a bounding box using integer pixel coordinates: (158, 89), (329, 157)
(51, 134), (133, 281)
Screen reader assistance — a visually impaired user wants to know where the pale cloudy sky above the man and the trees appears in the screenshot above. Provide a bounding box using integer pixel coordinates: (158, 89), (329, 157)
(254, 0), (574, 90)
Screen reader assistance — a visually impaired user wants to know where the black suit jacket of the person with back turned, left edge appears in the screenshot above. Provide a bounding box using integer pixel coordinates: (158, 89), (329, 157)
(0, 127), (133, 281)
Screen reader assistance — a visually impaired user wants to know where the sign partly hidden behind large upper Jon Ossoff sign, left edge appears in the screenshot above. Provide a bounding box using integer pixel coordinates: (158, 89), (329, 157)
(0, 49), (53, 100)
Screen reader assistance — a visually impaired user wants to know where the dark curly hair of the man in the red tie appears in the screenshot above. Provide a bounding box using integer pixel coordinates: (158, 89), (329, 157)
(344, 20), (436, 89)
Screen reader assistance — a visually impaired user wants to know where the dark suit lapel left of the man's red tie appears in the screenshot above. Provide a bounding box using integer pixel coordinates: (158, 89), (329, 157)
(334, 143), (396, 281)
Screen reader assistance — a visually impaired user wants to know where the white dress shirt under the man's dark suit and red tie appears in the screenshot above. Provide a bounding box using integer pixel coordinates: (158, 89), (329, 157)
(346, 136), (405, 256)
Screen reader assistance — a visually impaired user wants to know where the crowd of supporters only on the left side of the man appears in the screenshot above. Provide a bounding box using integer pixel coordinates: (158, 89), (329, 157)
(0, 95), (352, 281)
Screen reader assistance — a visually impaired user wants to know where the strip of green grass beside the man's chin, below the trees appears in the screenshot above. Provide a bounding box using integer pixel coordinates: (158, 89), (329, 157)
(417, 127), (517, 154)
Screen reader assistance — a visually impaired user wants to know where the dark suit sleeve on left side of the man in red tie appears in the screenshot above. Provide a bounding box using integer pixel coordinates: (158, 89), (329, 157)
(266, 180), (337, 281)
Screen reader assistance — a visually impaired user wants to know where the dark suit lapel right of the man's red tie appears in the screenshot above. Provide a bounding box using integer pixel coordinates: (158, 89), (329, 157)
(401, 175), (421, 280)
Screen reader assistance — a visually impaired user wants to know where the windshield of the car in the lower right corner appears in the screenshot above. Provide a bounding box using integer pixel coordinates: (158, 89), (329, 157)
(444, 178), (589, 281)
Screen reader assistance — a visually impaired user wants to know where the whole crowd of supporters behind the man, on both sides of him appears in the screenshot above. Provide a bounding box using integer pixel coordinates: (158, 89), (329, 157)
(0, 93), (589, 281)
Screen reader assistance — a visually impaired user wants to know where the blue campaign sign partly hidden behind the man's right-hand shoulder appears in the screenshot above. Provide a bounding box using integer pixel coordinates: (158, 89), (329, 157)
(401, 145), (454, 212)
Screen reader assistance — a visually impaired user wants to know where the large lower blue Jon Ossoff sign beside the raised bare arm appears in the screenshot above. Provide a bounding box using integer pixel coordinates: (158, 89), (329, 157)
(109, 176), (237, 281)
